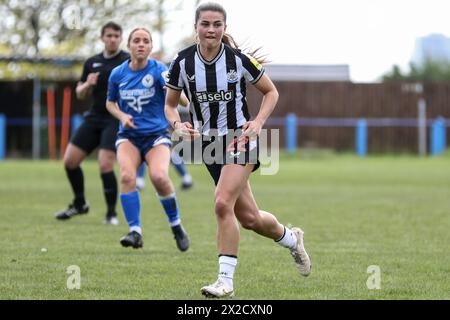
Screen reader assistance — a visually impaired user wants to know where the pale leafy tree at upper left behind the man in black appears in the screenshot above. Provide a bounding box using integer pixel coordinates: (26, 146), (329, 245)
(0, 0), (188, 57)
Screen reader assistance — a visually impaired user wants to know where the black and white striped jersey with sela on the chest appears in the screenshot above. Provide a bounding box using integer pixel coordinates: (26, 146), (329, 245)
(167, 44), (264, 136)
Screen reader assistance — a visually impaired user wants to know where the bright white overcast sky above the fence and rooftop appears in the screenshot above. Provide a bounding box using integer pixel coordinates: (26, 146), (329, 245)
(160, 0), (450, 82)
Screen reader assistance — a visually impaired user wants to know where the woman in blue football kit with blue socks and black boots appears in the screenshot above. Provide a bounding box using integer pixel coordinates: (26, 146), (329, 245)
(106, 28), (189, 251)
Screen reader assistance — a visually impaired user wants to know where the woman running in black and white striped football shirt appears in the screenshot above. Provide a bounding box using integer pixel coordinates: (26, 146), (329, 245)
(165, 3), (311, 297)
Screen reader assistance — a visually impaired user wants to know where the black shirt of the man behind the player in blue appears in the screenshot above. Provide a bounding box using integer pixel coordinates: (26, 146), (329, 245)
(80, 50), (130, 116)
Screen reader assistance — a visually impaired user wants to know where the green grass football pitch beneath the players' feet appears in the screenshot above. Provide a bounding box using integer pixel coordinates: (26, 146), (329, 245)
(0, 154), (450, 300)
